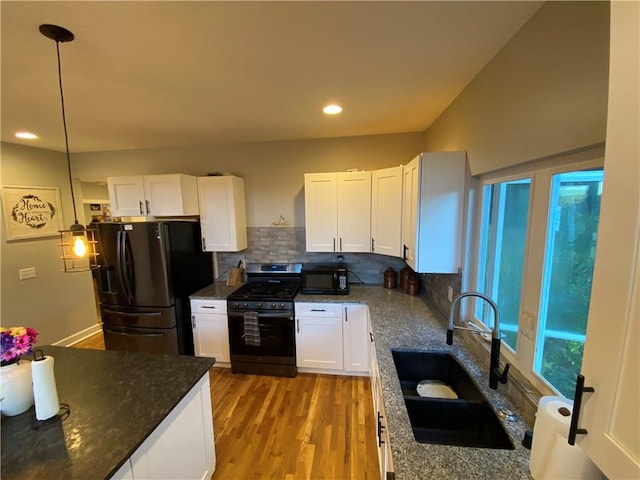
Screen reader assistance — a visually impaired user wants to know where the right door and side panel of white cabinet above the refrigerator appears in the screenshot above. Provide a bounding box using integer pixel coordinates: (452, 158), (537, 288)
(144, 174), (198, 216)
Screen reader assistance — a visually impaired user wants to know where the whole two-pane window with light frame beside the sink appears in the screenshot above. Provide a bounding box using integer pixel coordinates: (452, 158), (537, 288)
(465, 154), (603, 397)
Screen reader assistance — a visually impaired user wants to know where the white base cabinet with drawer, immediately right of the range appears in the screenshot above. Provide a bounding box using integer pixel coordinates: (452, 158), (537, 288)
(295, 303), (344, 373)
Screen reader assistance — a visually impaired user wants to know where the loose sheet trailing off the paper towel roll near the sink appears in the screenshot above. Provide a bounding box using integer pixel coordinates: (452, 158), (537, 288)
(544, 433), (604, 480)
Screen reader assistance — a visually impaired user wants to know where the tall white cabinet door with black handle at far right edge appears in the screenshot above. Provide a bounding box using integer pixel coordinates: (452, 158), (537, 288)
(576, 2), (640, 478)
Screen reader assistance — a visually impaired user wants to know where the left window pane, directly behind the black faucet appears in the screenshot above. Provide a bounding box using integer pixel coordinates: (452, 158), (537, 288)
(476, 178), (531, 350)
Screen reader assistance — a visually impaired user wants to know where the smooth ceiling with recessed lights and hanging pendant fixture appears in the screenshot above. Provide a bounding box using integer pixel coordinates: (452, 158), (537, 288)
(0, 0), (542, 152)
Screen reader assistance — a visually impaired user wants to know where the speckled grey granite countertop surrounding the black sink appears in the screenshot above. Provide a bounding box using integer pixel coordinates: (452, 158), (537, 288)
(296, 286), (531, 480)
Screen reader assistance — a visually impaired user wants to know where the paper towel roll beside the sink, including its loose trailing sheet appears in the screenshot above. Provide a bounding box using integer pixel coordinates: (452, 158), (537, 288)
(529, 397), (604, 480)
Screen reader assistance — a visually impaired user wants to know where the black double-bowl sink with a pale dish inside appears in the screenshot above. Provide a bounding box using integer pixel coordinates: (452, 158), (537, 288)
(391, 350), (514, 450)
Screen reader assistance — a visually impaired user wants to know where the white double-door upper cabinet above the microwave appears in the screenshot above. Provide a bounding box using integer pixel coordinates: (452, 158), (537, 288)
(304, 172), (371, 252)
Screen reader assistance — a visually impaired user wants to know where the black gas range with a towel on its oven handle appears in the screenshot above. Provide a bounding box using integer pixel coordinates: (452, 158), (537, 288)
(227, 263), (302, 377)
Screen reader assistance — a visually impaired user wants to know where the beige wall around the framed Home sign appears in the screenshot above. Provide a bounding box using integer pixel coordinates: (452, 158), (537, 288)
(0, 143), (97, 345)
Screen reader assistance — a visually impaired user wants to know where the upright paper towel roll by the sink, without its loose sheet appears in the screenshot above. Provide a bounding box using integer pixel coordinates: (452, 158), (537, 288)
(529, 397), (573, 480)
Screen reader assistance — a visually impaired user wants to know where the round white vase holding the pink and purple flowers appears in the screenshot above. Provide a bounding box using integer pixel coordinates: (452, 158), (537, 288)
(0, 361), (33, 417)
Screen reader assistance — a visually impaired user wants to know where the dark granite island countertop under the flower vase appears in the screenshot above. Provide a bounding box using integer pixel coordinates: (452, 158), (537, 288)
(1, 346), (215, 479)
